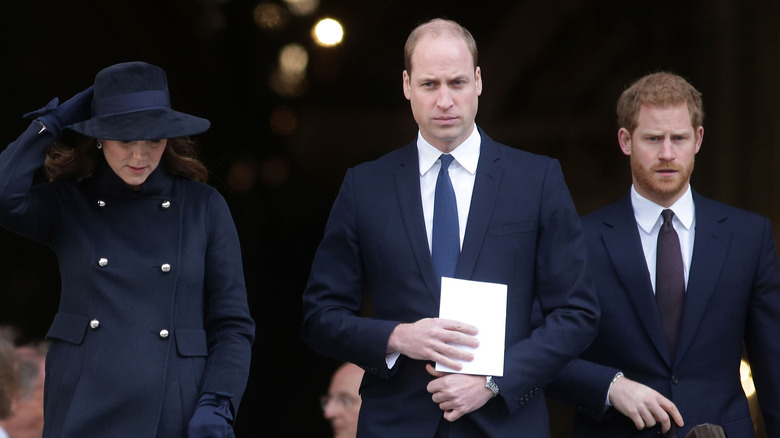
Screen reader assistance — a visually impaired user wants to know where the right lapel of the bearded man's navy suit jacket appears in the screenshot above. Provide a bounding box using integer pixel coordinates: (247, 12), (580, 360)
(677, 192), (731, 360)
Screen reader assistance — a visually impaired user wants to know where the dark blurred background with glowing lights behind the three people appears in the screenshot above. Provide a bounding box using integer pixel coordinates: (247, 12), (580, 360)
(0, 0), (780, 437)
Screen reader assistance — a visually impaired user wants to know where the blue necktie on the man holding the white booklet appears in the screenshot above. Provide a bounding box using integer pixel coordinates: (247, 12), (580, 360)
(431, 154), (460, 279)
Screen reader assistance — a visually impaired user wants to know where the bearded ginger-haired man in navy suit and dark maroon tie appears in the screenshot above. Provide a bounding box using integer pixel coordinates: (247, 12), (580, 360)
(548, 73), (780, 438)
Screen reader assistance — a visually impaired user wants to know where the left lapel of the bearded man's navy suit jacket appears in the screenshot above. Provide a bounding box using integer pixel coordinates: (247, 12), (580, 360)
(602, 195), (670, 363)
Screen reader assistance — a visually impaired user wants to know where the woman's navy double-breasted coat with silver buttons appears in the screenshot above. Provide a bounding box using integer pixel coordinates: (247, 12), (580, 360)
(0, 122), (254, 438)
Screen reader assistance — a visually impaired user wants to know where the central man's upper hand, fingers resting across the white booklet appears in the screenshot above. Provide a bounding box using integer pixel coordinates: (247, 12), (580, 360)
(387, 318), (479, 370)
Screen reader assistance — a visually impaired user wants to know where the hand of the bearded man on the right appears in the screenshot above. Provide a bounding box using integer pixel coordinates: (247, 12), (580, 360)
(609, 377), (684, 433)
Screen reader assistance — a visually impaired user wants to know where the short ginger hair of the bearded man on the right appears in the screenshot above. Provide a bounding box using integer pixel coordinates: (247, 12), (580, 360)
(617, 72), (704, 133)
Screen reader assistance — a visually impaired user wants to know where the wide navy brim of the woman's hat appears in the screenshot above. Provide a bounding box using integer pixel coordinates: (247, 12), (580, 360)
(65, 108), (211, 141)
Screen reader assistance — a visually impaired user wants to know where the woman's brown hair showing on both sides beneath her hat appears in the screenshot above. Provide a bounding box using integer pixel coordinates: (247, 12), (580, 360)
(43, 135), (209, 183)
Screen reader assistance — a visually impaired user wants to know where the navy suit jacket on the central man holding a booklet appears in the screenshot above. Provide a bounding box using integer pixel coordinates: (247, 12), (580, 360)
(303, 128), (598, 437)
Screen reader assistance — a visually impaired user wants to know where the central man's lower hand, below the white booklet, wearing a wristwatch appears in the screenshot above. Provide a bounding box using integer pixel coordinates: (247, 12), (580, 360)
(425, 364), (493, 421)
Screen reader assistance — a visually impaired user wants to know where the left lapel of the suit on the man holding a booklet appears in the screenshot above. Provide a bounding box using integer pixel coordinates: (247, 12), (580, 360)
(395, 143), (440, 304)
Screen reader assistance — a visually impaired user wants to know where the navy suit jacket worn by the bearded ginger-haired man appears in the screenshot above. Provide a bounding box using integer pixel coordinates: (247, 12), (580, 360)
(549, 192), (780, 438)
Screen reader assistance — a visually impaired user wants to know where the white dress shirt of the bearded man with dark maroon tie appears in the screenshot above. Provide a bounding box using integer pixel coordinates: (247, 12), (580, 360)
(631, 185), (696, 291)
